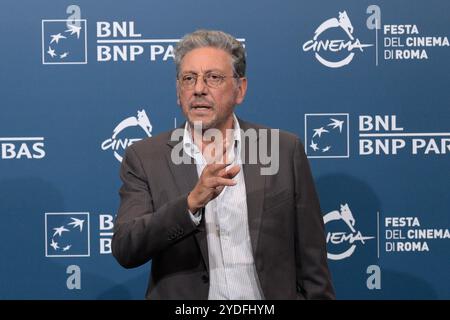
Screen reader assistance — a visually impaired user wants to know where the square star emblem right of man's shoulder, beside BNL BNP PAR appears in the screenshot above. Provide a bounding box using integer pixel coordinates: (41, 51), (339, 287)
(304, 113), (350, 158)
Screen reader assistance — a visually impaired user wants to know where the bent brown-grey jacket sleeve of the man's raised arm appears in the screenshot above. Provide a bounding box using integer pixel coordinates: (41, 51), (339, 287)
(112, 146), (196, 268)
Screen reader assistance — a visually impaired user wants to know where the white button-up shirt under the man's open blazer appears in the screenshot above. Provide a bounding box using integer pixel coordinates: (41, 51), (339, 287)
(183, 115), (263, 300)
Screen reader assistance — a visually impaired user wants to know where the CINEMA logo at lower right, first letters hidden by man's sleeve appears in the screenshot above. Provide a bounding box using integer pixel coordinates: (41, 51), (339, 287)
(323, 203), (375, 260)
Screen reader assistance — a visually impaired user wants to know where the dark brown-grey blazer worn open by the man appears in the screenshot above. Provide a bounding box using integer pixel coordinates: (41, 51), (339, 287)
(112, 120), (334, 300)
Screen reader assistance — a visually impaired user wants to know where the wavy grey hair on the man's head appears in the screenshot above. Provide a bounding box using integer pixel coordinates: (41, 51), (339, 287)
(175, 30), (246, 77)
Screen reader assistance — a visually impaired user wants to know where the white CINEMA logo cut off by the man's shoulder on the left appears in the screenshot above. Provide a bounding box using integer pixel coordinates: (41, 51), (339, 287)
(101, 109), (152, 162)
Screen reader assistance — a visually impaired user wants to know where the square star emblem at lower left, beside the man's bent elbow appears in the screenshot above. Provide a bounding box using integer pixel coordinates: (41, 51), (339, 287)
(45, 212), (90, 257)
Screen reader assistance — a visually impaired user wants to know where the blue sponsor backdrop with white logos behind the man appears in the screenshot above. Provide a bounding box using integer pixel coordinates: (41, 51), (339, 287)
(0, 0), (450, 299)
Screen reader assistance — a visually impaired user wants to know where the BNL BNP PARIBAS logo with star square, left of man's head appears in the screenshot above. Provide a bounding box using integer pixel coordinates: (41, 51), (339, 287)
(42, 5), (245, 64)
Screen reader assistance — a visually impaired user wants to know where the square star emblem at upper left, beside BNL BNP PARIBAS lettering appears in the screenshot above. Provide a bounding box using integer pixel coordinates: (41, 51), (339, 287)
(42, 19), (87, 64)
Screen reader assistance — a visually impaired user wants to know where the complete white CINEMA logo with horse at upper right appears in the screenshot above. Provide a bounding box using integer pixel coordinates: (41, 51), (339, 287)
(303, 11), (373, 68)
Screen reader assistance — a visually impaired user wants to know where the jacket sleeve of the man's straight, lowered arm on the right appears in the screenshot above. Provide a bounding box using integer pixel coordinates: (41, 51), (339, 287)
(294, 138), (335, 299)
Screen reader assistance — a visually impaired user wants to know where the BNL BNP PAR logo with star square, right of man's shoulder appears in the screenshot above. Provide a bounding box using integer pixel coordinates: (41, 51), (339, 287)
(304, 113), (450, 158)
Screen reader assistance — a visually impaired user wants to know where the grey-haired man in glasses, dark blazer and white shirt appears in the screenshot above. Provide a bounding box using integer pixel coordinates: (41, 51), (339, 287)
(112, 30), (334, 299)
